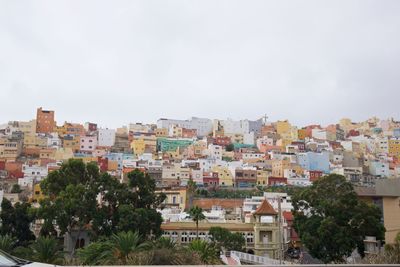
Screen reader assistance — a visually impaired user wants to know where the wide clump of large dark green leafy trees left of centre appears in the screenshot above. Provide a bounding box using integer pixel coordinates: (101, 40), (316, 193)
(38, 159), (165, 247)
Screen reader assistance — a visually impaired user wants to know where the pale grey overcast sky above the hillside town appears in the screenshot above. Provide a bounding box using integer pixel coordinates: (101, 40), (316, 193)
(0, 0), (400, 127)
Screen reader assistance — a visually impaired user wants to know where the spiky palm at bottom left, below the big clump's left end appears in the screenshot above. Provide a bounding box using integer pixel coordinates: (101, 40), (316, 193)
(30, 236), (64, 264)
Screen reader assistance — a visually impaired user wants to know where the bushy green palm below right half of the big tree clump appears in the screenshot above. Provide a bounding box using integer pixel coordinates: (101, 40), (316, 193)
(110, 231), (149, 265)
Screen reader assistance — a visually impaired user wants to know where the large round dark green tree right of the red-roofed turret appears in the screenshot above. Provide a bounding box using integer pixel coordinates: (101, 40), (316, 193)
(292, 174), (384, 263)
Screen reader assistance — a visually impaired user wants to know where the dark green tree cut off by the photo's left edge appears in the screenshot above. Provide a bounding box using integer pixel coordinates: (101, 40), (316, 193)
(0, 198), (35, 246)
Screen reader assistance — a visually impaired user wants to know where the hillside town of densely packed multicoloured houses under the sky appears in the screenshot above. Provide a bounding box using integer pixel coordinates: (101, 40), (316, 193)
(0, 108), (400, 264)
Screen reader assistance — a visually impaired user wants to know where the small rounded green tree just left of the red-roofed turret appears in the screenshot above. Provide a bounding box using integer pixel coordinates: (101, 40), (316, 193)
(209, 227), (246, 251)
